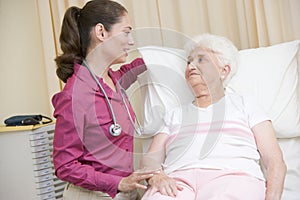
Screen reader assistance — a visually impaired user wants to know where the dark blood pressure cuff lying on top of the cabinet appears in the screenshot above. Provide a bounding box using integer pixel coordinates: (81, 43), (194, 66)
(4, 115), (52, 126)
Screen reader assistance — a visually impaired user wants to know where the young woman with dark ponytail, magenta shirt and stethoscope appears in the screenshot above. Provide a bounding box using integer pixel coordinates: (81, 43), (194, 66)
(52, 0), (153, 200)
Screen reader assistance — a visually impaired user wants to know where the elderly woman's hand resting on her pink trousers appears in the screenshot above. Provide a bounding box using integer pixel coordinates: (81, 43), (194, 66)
(148, 171), (183, 197)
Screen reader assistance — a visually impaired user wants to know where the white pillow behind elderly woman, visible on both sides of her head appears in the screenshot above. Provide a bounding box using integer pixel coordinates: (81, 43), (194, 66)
(138, 40), (300, 138)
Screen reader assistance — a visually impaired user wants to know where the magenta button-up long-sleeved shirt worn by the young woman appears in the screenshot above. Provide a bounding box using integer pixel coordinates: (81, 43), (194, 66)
(52, 58), (146, 197)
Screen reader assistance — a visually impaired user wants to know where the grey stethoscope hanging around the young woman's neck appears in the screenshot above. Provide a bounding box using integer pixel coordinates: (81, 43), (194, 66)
(83, 60), (143, 137)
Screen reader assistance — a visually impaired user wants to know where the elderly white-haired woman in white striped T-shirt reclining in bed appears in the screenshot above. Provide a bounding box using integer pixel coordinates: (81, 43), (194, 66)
(141, 34), (286, 200)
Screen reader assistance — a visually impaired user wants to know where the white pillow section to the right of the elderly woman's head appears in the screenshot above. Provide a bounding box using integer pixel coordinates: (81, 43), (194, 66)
(227, 40), (300, 138)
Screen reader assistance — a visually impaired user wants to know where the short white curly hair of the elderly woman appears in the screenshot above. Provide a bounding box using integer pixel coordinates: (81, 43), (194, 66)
(184, 33), (238, 86)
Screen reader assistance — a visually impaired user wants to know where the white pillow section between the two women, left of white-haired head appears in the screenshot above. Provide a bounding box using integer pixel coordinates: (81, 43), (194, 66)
(138, 46), (193, 135)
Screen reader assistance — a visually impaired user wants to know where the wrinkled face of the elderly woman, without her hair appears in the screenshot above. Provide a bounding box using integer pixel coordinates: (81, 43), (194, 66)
(185, 47), (222, 90)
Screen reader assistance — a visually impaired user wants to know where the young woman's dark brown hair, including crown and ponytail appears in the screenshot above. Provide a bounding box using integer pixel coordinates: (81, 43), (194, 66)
(55, 0), (127, 82)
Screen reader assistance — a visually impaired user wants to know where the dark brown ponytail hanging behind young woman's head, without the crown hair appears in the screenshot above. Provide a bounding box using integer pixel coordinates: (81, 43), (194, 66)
(55, 7), (82, 82)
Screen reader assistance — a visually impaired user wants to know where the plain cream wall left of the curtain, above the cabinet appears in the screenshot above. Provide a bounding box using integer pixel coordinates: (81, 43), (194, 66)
(0, 0), (52, 124)
